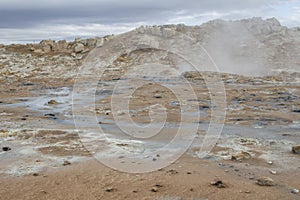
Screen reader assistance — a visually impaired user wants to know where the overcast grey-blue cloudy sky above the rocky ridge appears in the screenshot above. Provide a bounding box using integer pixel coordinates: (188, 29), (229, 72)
(0, 0), (300, 43)
